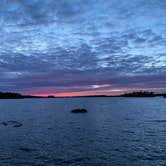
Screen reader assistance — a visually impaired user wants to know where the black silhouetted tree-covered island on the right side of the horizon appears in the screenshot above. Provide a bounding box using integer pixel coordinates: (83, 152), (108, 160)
(121, 91), (157, 97)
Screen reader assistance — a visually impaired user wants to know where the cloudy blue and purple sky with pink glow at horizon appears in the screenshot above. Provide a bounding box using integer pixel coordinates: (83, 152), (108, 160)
(0, 0), (166, 96)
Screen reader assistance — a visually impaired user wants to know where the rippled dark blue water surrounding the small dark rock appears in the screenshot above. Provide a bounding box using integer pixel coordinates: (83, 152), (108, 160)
(0, 98), (166, 166)
